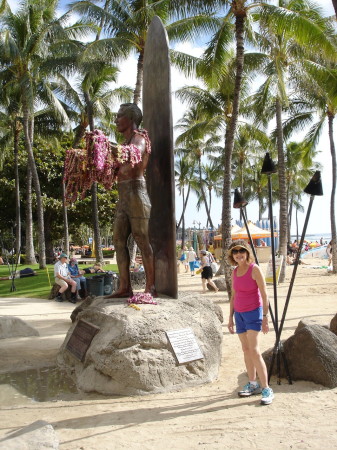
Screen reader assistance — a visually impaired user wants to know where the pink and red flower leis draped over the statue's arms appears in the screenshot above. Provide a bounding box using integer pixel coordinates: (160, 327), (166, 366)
(63, 130), (151, 203)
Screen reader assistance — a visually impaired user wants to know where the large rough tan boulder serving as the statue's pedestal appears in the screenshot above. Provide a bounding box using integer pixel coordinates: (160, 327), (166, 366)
(58, 294), (222, 395)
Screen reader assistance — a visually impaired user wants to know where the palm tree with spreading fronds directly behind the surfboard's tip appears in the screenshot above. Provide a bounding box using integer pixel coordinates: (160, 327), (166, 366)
(72, 0), (221, 104)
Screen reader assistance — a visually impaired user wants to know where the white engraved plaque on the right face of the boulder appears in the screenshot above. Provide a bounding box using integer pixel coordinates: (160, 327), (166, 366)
(166, 328), (204, 364)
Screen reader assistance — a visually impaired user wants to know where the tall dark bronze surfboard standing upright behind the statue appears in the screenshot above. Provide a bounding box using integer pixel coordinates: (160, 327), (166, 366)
(143, 16), (178, 298)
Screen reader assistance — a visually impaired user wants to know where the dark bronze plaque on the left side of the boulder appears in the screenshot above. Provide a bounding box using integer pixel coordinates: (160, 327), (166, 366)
(66, 320), (99, 361)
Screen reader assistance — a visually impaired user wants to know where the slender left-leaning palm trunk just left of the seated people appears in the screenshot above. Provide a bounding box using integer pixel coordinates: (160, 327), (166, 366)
(22, 103), (46, 269)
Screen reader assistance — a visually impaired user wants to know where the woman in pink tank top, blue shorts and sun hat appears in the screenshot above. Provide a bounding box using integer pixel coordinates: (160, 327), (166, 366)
(228, 239), (274, 405)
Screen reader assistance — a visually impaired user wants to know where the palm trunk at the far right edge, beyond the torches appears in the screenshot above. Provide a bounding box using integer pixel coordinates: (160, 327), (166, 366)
(328, 113), (337, 273)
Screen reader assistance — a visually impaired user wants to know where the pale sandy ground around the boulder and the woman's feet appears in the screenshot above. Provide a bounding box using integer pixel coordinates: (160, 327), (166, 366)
(0, 260), (337, 450)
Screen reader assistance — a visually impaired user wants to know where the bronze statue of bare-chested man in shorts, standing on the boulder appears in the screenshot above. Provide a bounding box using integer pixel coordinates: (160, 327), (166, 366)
(106, 103), (157, 298)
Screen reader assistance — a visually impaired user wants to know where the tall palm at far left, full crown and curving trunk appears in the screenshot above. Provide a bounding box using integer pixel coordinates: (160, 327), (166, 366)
(0, 0), (88, 268)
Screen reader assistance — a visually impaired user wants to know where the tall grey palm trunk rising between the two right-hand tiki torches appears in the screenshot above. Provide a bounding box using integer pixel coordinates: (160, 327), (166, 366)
(276, 98), (288, 283)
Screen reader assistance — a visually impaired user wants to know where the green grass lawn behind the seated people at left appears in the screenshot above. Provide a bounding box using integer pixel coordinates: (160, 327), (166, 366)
(0, 264), (118, 299)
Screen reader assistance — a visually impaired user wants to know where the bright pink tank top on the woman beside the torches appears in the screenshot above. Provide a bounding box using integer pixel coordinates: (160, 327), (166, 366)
(233, 263), (262, 312)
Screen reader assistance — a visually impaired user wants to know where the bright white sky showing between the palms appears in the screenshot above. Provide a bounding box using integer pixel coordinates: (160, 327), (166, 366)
(7, 0), (337, 234)
